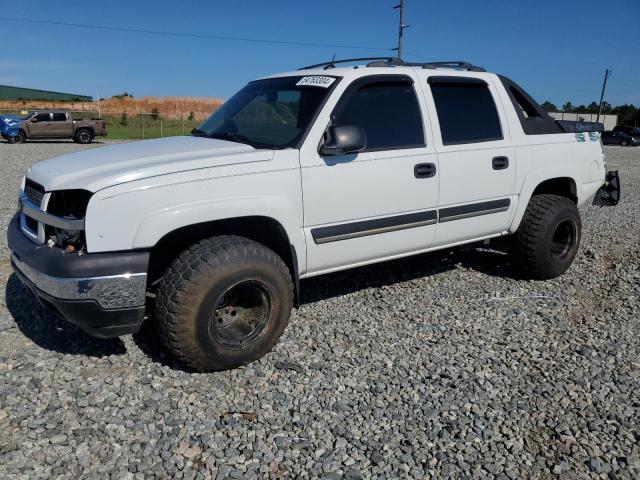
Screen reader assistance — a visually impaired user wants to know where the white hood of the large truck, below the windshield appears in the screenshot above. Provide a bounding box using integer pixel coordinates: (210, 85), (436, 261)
(27, 137), (273, 192)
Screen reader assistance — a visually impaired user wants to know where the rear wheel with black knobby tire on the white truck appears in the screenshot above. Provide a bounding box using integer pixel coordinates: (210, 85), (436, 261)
(514, 195), (582, 280)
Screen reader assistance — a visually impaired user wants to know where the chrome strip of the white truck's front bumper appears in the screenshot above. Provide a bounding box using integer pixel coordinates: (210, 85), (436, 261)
(11, 252), (147, 310)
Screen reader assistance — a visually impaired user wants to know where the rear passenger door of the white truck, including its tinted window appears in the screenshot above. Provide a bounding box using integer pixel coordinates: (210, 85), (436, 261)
(424, 74), (516, 245)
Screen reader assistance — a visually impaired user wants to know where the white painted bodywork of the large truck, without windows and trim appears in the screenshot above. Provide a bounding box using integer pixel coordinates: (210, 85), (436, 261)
(20, 62), (605, 277)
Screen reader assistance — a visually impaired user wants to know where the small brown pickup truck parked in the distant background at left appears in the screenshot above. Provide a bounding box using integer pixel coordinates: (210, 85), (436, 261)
(14, 110), (107, 143)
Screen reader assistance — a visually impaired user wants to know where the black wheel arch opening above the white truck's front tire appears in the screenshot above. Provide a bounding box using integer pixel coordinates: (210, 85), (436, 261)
(148, 215), (300, 307)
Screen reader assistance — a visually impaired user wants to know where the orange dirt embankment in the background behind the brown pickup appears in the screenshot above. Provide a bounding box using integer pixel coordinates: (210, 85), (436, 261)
(0, 97), (223, 120)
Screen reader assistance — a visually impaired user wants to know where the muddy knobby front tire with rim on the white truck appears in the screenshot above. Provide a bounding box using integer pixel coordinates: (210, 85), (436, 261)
(156, 236), (293, 372)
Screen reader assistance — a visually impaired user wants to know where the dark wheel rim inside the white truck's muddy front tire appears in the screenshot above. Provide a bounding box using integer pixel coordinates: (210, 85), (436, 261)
(209, 280), (273, 349)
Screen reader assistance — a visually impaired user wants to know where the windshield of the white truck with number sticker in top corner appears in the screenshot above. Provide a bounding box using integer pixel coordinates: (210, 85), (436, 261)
(193, 76), (337, 149)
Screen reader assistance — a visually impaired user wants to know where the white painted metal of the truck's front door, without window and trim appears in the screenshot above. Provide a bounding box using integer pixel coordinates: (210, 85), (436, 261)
(300, 69), (438, 272)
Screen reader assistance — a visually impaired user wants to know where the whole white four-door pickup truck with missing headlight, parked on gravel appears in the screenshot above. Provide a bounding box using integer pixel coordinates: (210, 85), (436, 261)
(8, 59), (619, 371)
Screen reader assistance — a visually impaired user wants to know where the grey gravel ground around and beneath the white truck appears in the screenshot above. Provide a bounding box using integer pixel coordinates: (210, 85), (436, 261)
(0, 143), (640, 480)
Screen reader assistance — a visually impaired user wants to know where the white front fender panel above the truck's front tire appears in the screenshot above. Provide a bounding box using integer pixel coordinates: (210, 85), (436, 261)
(86, 150), (305, 269)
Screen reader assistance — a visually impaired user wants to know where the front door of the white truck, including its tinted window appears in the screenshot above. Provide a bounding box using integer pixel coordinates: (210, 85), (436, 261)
(301, 75), (438, 275)
